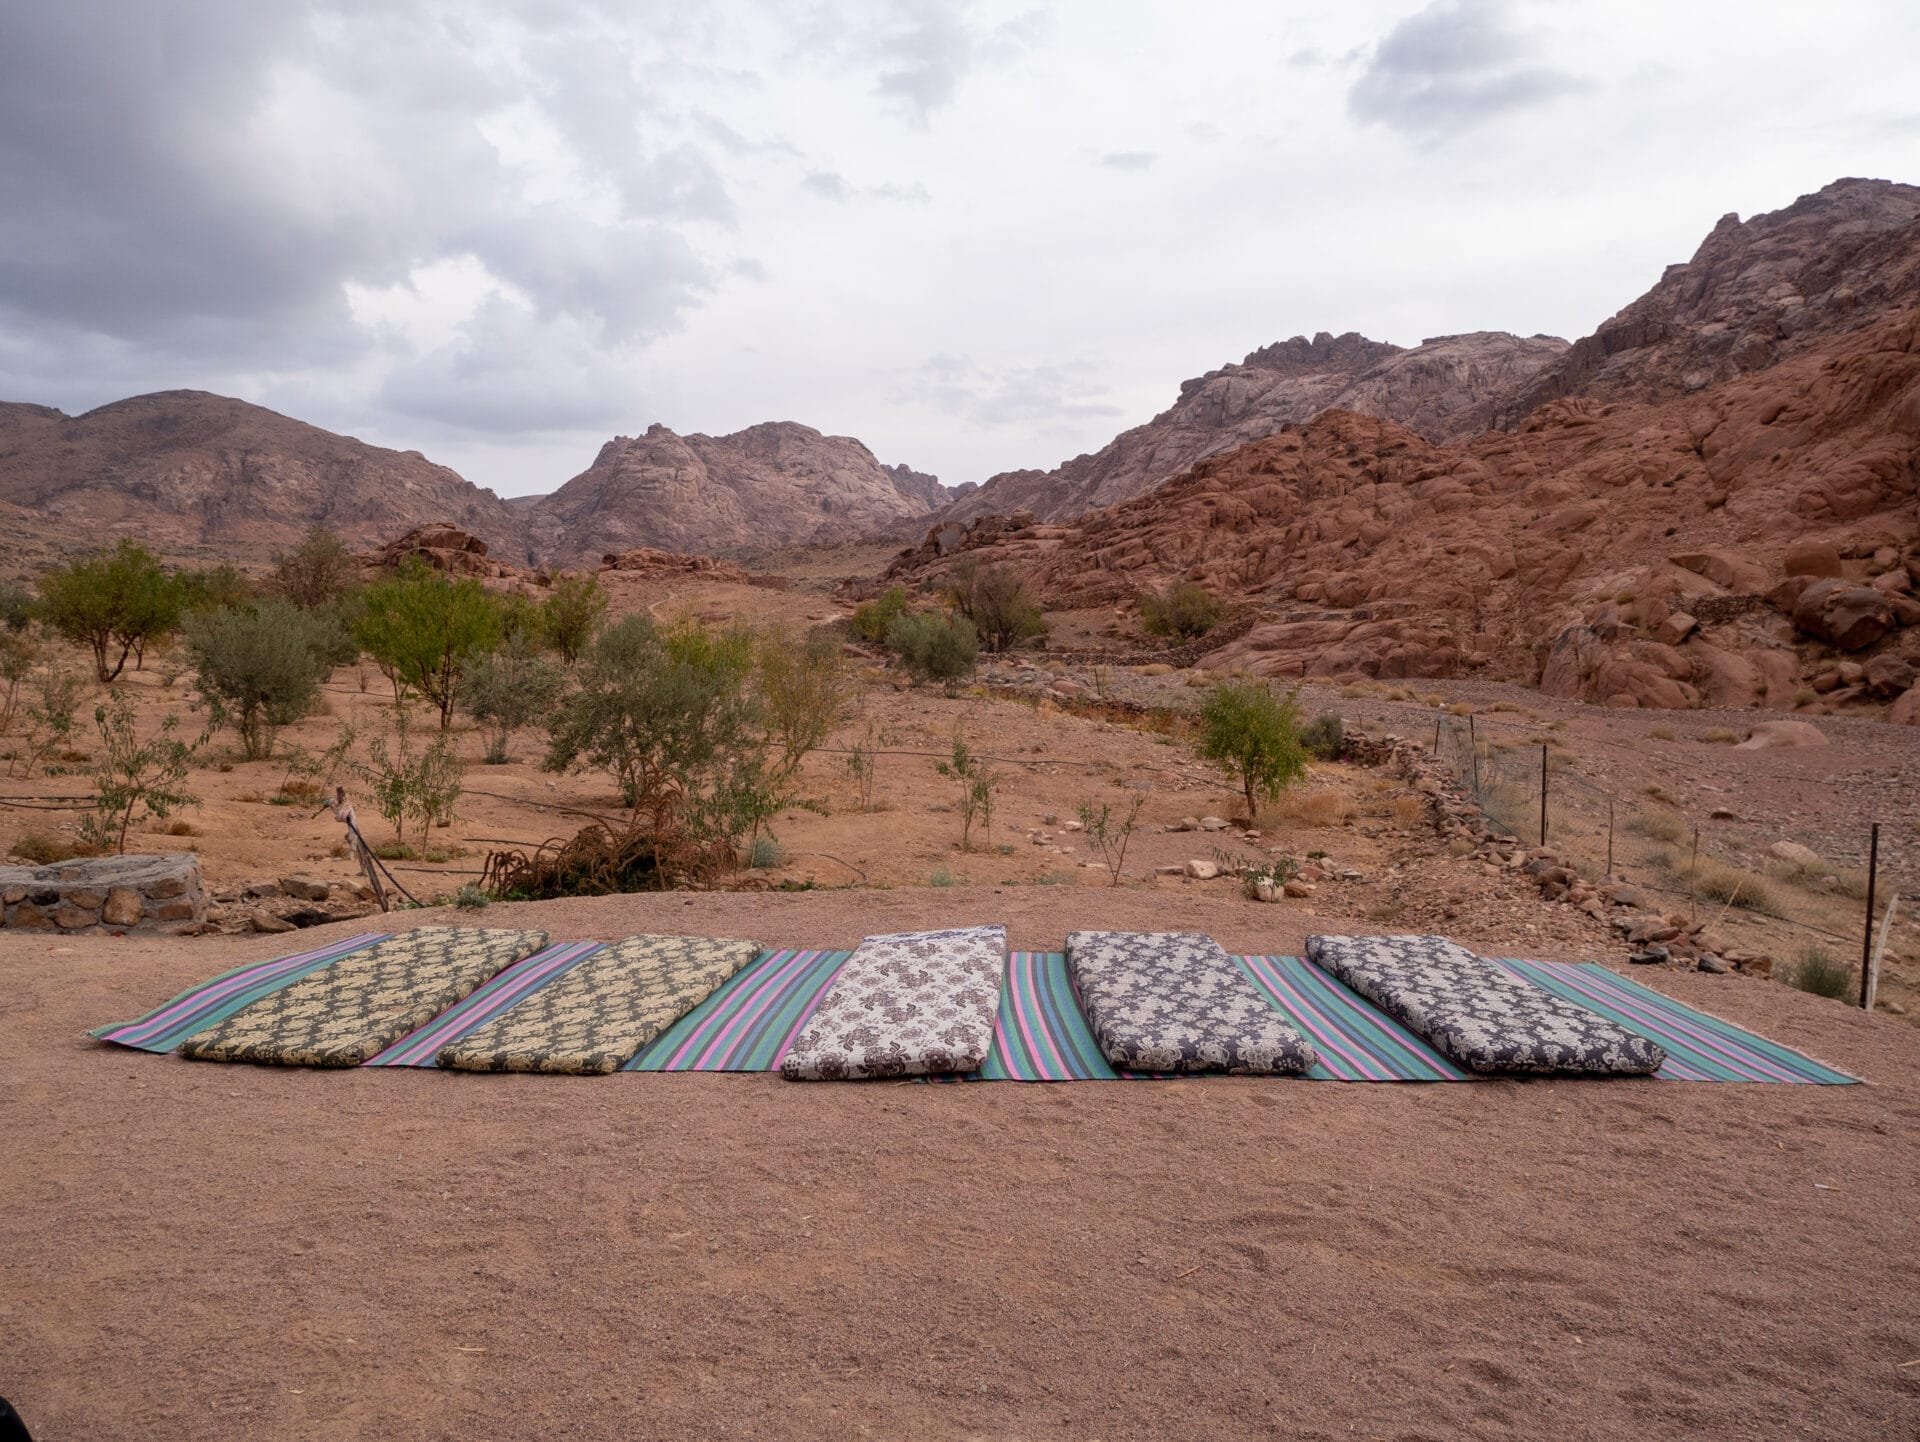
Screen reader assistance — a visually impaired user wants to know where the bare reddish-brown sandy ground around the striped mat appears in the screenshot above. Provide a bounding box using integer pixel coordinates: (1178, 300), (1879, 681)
(0, 887), (1920, 1442)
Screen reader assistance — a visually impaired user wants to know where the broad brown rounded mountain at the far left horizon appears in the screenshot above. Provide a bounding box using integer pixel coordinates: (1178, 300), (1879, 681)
(0, 390), (526, 555)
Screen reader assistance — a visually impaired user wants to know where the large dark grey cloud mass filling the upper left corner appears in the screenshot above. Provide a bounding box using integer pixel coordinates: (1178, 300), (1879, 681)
(0, 0), (732, 367)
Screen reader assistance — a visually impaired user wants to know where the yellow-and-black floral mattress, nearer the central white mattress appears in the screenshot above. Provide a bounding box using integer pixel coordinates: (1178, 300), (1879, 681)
(440, 937), (760, 1075)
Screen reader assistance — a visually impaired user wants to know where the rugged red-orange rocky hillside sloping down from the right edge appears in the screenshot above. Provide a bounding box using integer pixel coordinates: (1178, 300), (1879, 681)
(891, 307), (1920, 720)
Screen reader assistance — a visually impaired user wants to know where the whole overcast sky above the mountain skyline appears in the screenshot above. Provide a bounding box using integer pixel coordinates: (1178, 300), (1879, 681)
(0, 0), (1920, 495)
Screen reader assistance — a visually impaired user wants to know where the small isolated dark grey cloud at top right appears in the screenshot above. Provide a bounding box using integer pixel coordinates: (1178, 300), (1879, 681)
(1348, 0), (1588, 142)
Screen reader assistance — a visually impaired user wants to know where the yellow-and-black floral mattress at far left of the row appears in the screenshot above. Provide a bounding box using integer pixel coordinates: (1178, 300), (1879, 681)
(180, 925), (547, 1066)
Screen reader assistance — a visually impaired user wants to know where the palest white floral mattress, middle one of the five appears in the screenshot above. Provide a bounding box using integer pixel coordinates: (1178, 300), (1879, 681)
(780, 925), (1006, 1081)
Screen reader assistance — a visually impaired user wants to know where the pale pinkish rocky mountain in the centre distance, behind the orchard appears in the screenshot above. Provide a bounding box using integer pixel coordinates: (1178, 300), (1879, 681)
(526, 421), (948, 565)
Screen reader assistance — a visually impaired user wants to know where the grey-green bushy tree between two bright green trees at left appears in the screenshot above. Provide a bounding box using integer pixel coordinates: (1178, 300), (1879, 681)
(186, 601), (338, 760)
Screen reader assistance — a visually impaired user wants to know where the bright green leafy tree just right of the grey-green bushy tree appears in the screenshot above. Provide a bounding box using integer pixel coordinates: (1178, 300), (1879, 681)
(353, 557), (501, 732)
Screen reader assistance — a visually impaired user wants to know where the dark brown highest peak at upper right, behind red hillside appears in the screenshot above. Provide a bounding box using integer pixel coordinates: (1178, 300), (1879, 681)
(1500, 179), (1920, 426)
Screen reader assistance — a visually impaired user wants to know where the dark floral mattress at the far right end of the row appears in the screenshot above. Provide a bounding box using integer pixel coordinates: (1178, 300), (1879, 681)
(1308, 937), (1667, 1075)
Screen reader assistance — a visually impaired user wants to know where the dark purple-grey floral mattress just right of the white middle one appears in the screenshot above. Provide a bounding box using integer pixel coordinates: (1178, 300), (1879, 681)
(1068, 931), (1319, 1073)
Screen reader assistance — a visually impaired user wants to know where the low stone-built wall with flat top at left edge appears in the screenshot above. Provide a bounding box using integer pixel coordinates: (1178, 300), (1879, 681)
(0, 853), (207, 933)
